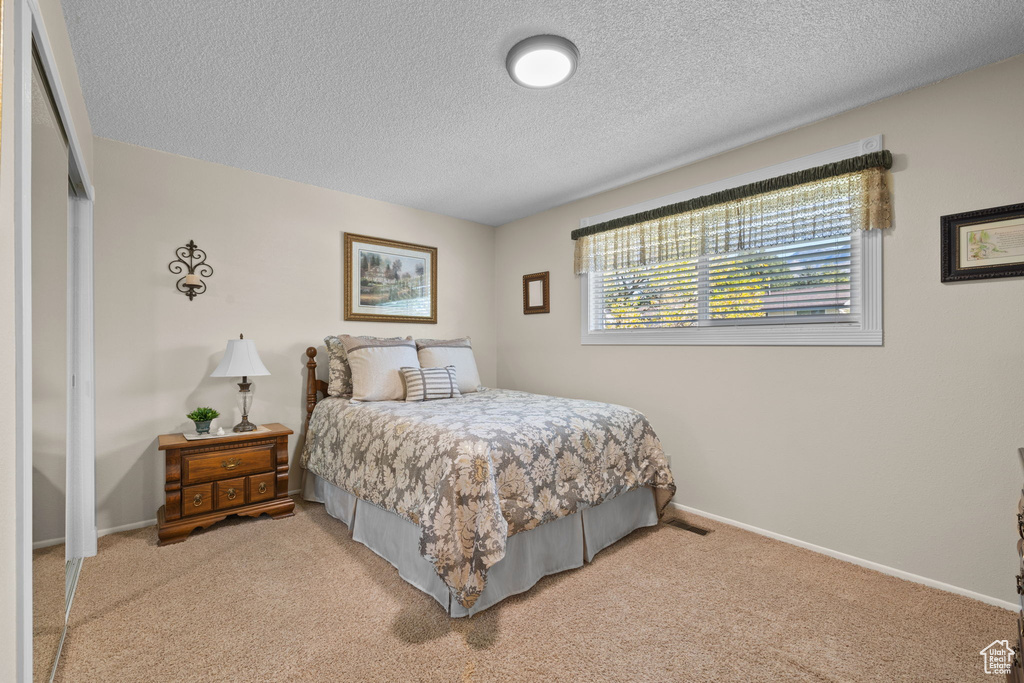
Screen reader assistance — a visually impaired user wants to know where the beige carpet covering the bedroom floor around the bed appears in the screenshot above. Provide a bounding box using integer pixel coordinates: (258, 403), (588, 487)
(57, 504), (1015, 682)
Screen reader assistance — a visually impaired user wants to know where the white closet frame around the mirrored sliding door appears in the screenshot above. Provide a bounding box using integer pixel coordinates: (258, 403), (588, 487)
(14, 0), (96, 683)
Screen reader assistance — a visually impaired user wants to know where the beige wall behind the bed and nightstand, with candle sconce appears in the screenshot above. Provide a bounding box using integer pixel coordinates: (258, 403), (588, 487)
(95, 138), (497, 529)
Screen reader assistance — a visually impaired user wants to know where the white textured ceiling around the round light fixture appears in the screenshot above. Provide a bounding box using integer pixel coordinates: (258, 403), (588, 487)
(62, 0), (1024, 225)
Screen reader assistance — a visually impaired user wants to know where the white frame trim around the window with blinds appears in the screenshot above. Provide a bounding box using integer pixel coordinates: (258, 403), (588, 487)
(580, 135), (883, 346)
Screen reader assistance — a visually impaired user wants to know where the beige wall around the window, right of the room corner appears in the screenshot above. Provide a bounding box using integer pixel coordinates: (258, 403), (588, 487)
(497, 57), (1024, 601)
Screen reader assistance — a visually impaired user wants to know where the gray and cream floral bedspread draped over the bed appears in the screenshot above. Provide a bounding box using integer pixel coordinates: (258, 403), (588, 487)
(302, 389), (676, 607)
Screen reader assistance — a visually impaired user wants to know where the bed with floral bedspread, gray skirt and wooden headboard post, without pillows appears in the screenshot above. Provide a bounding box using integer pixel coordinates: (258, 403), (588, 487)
(302, 347), (676, 616)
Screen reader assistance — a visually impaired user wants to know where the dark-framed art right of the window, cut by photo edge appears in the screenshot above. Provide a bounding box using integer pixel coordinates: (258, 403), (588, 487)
(941, 204), (1024, 283)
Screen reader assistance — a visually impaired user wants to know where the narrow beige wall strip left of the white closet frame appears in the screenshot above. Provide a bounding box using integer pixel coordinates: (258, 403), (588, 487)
(0, 0), (17, 681)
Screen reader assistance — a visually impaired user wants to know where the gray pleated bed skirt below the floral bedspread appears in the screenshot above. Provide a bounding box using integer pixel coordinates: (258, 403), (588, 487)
(302, 471), (657, 616)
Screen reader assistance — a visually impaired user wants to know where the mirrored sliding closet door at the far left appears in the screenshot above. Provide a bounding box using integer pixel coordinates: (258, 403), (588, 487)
(32, 50), (70, 681)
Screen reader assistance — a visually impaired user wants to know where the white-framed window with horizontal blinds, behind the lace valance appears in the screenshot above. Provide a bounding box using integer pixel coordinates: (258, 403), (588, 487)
(578, 138), (882, 345)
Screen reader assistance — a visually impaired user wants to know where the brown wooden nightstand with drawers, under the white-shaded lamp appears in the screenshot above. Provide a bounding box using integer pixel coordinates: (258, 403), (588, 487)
(157, 423), (295, 546)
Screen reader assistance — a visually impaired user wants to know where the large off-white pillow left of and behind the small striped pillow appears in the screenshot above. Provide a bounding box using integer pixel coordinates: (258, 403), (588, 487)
(341, 335), (420, 400)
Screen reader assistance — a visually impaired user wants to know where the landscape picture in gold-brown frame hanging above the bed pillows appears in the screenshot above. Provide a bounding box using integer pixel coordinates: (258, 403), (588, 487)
(343, 232), (437, 323)
